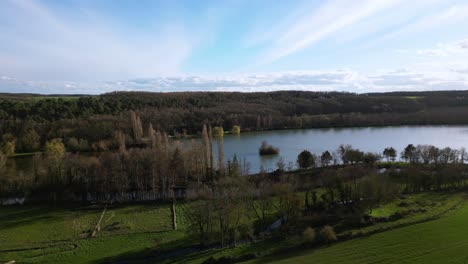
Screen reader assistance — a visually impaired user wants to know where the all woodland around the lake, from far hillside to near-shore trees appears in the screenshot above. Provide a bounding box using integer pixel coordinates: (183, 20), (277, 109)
(0, 92), (468, 250)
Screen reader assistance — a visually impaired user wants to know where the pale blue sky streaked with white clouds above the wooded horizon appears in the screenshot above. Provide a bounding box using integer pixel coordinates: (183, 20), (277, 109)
(0, 0), (468, 94)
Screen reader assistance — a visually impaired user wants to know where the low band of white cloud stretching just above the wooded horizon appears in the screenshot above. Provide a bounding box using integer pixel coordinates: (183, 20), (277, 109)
(0, 65), (468, 94)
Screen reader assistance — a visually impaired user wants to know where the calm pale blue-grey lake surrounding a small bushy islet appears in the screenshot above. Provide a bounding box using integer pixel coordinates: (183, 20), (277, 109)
(209, 126), (468, 173)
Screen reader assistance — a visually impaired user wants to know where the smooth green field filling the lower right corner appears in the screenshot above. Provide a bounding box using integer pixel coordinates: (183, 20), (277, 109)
(252, 193), (468, 263)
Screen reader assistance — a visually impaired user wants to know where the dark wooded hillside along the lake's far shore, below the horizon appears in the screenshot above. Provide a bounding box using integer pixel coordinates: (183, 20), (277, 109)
(0, 91), (468, 154)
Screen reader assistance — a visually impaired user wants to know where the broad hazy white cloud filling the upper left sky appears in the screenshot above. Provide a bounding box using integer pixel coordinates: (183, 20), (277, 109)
(0, 0), (201, 81)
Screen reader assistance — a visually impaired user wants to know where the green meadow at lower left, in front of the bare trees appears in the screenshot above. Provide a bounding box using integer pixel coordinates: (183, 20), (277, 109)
(0, 204), (184, 263)
